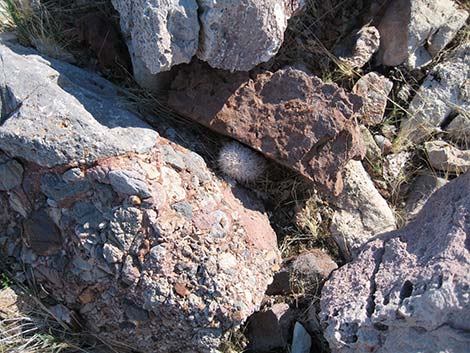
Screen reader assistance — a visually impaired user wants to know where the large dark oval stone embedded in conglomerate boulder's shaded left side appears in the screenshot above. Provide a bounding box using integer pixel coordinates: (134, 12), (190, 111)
(23, 210), (63, 256)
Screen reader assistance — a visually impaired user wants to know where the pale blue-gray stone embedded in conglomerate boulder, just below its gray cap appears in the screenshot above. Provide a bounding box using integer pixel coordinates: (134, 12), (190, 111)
(108, 170), (152, 199)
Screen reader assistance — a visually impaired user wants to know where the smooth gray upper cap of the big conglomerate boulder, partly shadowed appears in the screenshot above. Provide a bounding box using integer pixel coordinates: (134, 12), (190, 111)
(0, 43), (158, 167)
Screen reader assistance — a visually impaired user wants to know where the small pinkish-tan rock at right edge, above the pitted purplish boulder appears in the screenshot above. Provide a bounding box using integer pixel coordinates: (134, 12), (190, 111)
(424, 141), (470, 174)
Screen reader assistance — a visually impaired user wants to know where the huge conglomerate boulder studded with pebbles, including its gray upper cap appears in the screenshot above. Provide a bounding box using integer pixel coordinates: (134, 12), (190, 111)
(0, 46), (279, 353)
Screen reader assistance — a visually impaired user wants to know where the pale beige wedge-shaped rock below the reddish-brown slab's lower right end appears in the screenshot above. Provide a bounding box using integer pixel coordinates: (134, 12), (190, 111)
(330, 161), (396, 259)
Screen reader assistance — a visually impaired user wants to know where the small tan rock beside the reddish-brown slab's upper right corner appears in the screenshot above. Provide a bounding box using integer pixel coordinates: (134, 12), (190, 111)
(352, 72), (393, 126)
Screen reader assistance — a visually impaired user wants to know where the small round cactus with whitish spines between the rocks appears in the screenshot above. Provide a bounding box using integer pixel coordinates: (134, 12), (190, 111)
(218, 142), (266, 183)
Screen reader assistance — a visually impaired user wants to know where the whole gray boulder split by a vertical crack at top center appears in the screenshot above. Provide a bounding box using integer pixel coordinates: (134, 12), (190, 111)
(112, 0), (306, 87)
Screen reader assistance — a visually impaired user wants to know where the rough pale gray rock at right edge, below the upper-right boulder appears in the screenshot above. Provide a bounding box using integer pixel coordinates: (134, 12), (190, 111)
(400, 44), (470, 142)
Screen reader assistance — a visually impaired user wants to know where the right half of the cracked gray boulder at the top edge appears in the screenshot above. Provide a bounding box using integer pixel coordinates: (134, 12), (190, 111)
(197, 0), (306, 71)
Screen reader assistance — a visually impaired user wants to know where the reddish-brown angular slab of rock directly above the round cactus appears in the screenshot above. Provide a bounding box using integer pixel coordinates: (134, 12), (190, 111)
(169, 63), (365, 194)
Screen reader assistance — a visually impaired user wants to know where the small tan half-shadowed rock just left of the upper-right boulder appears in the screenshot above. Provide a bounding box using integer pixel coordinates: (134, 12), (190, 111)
(335, 26), (380, 70)
